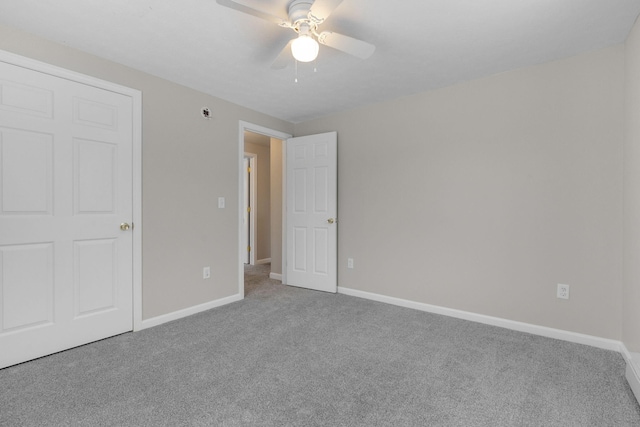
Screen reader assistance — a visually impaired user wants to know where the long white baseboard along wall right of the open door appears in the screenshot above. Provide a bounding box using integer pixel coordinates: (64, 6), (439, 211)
(338, 287), (622, 352)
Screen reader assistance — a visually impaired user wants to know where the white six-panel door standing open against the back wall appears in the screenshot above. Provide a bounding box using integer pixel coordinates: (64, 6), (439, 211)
(286, 132), (338, 292)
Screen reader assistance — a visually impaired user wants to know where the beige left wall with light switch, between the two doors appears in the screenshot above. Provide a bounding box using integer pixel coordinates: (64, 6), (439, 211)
(0, 22), (293, 319)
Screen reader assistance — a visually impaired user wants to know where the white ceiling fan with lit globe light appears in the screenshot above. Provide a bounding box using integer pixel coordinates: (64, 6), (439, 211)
(216, 0), (376, 69)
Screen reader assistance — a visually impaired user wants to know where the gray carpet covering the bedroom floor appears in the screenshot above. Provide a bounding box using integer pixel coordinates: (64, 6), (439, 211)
(0, 266), (640, 426)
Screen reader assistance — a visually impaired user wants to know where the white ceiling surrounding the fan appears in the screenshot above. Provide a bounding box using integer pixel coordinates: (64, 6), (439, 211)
(0, 0), (640, 123)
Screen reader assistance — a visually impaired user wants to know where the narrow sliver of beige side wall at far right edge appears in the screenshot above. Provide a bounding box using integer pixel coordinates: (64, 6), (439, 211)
(622, 15), (640, 352)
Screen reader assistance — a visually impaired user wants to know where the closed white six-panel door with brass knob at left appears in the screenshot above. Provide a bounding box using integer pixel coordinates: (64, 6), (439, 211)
(0, 62), (133, 368)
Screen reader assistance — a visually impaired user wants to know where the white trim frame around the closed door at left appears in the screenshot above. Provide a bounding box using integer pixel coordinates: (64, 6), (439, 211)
(0, 50), (143, 331)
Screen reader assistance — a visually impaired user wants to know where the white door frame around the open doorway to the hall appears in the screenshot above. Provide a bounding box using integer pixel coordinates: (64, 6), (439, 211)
(237, 120), (293, 298)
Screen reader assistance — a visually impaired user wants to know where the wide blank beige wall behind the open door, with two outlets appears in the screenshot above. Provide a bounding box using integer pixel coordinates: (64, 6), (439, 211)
(295, 46), (624, 339)
